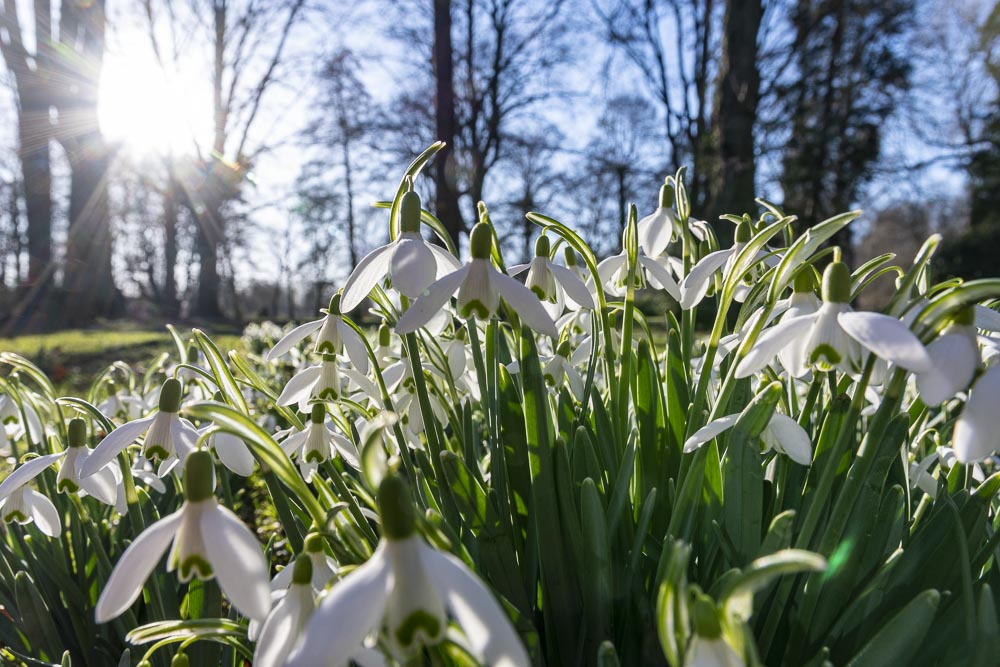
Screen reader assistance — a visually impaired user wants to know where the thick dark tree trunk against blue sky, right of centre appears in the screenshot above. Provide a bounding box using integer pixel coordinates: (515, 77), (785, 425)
(711, 0), (763, 220)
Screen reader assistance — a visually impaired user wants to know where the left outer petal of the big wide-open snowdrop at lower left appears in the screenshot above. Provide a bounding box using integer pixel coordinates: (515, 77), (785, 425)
(95, 509), (184, 623)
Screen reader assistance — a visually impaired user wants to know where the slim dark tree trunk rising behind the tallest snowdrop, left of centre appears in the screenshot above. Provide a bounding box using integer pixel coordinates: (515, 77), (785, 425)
(432, 0), (465, 248)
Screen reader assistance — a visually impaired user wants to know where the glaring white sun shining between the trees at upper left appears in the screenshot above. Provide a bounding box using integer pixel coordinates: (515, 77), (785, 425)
(97, 34), (212, 158)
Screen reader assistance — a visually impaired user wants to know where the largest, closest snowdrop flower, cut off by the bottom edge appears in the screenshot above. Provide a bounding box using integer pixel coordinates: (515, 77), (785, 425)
(288, 476), (530, 667)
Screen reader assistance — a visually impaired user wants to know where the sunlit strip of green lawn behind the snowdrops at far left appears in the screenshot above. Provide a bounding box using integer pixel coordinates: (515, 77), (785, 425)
(0, 324), (242, 395)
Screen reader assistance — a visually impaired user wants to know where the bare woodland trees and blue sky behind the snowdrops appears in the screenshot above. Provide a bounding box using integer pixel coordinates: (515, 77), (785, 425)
(0, 0), (1000, 330)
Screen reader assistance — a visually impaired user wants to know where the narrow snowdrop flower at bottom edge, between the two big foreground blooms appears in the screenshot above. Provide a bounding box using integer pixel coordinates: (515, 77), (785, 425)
(253, 554), (316, 667)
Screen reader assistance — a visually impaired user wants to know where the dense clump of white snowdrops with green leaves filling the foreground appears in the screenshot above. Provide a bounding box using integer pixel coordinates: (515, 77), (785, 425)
(0, 144), (1000, 667)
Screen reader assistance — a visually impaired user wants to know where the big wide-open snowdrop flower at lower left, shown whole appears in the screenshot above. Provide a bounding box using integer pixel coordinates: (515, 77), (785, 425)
(96, 450), (271, 623)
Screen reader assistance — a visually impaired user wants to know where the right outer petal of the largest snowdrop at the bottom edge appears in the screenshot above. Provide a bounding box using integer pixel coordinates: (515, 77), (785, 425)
(421, 544), (531, 667)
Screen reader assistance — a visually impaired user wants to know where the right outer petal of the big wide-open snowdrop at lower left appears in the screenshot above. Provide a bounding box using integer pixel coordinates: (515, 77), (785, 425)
(201, 505), (271, 620)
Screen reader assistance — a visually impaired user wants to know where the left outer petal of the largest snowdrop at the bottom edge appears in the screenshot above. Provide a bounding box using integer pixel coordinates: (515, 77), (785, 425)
(286, 542), (389, 667)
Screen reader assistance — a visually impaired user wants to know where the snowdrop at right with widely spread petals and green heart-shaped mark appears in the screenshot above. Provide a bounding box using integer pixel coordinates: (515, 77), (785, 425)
(736, 262), (931, 378)
